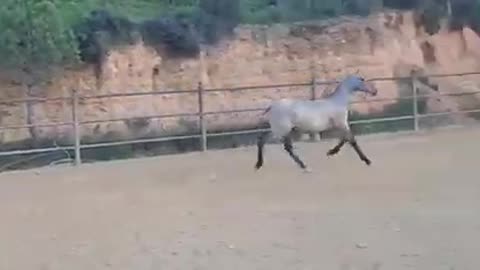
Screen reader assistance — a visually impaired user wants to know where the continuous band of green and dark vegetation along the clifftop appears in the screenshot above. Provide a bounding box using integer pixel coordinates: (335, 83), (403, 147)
(0, 0), (480, 72)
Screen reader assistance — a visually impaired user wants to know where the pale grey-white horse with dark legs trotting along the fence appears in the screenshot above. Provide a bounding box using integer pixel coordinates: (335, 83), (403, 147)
(255, 75), (377, 171)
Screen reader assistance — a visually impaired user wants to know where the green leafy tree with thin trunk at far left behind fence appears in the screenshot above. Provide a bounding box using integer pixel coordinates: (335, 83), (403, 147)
(0, 0), (77, 141)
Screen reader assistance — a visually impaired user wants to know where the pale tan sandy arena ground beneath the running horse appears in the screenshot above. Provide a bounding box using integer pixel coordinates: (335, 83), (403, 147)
(0, 129), (480, 270)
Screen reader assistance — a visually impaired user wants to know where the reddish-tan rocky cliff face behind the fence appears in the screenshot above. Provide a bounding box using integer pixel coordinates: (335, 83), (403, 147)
(0, 11), (480, 146)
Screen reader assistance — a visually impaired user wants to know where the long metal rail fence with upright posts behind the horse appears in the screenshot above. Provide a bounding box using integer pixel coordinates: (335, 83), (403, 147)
(0, 72), (480, 165)
